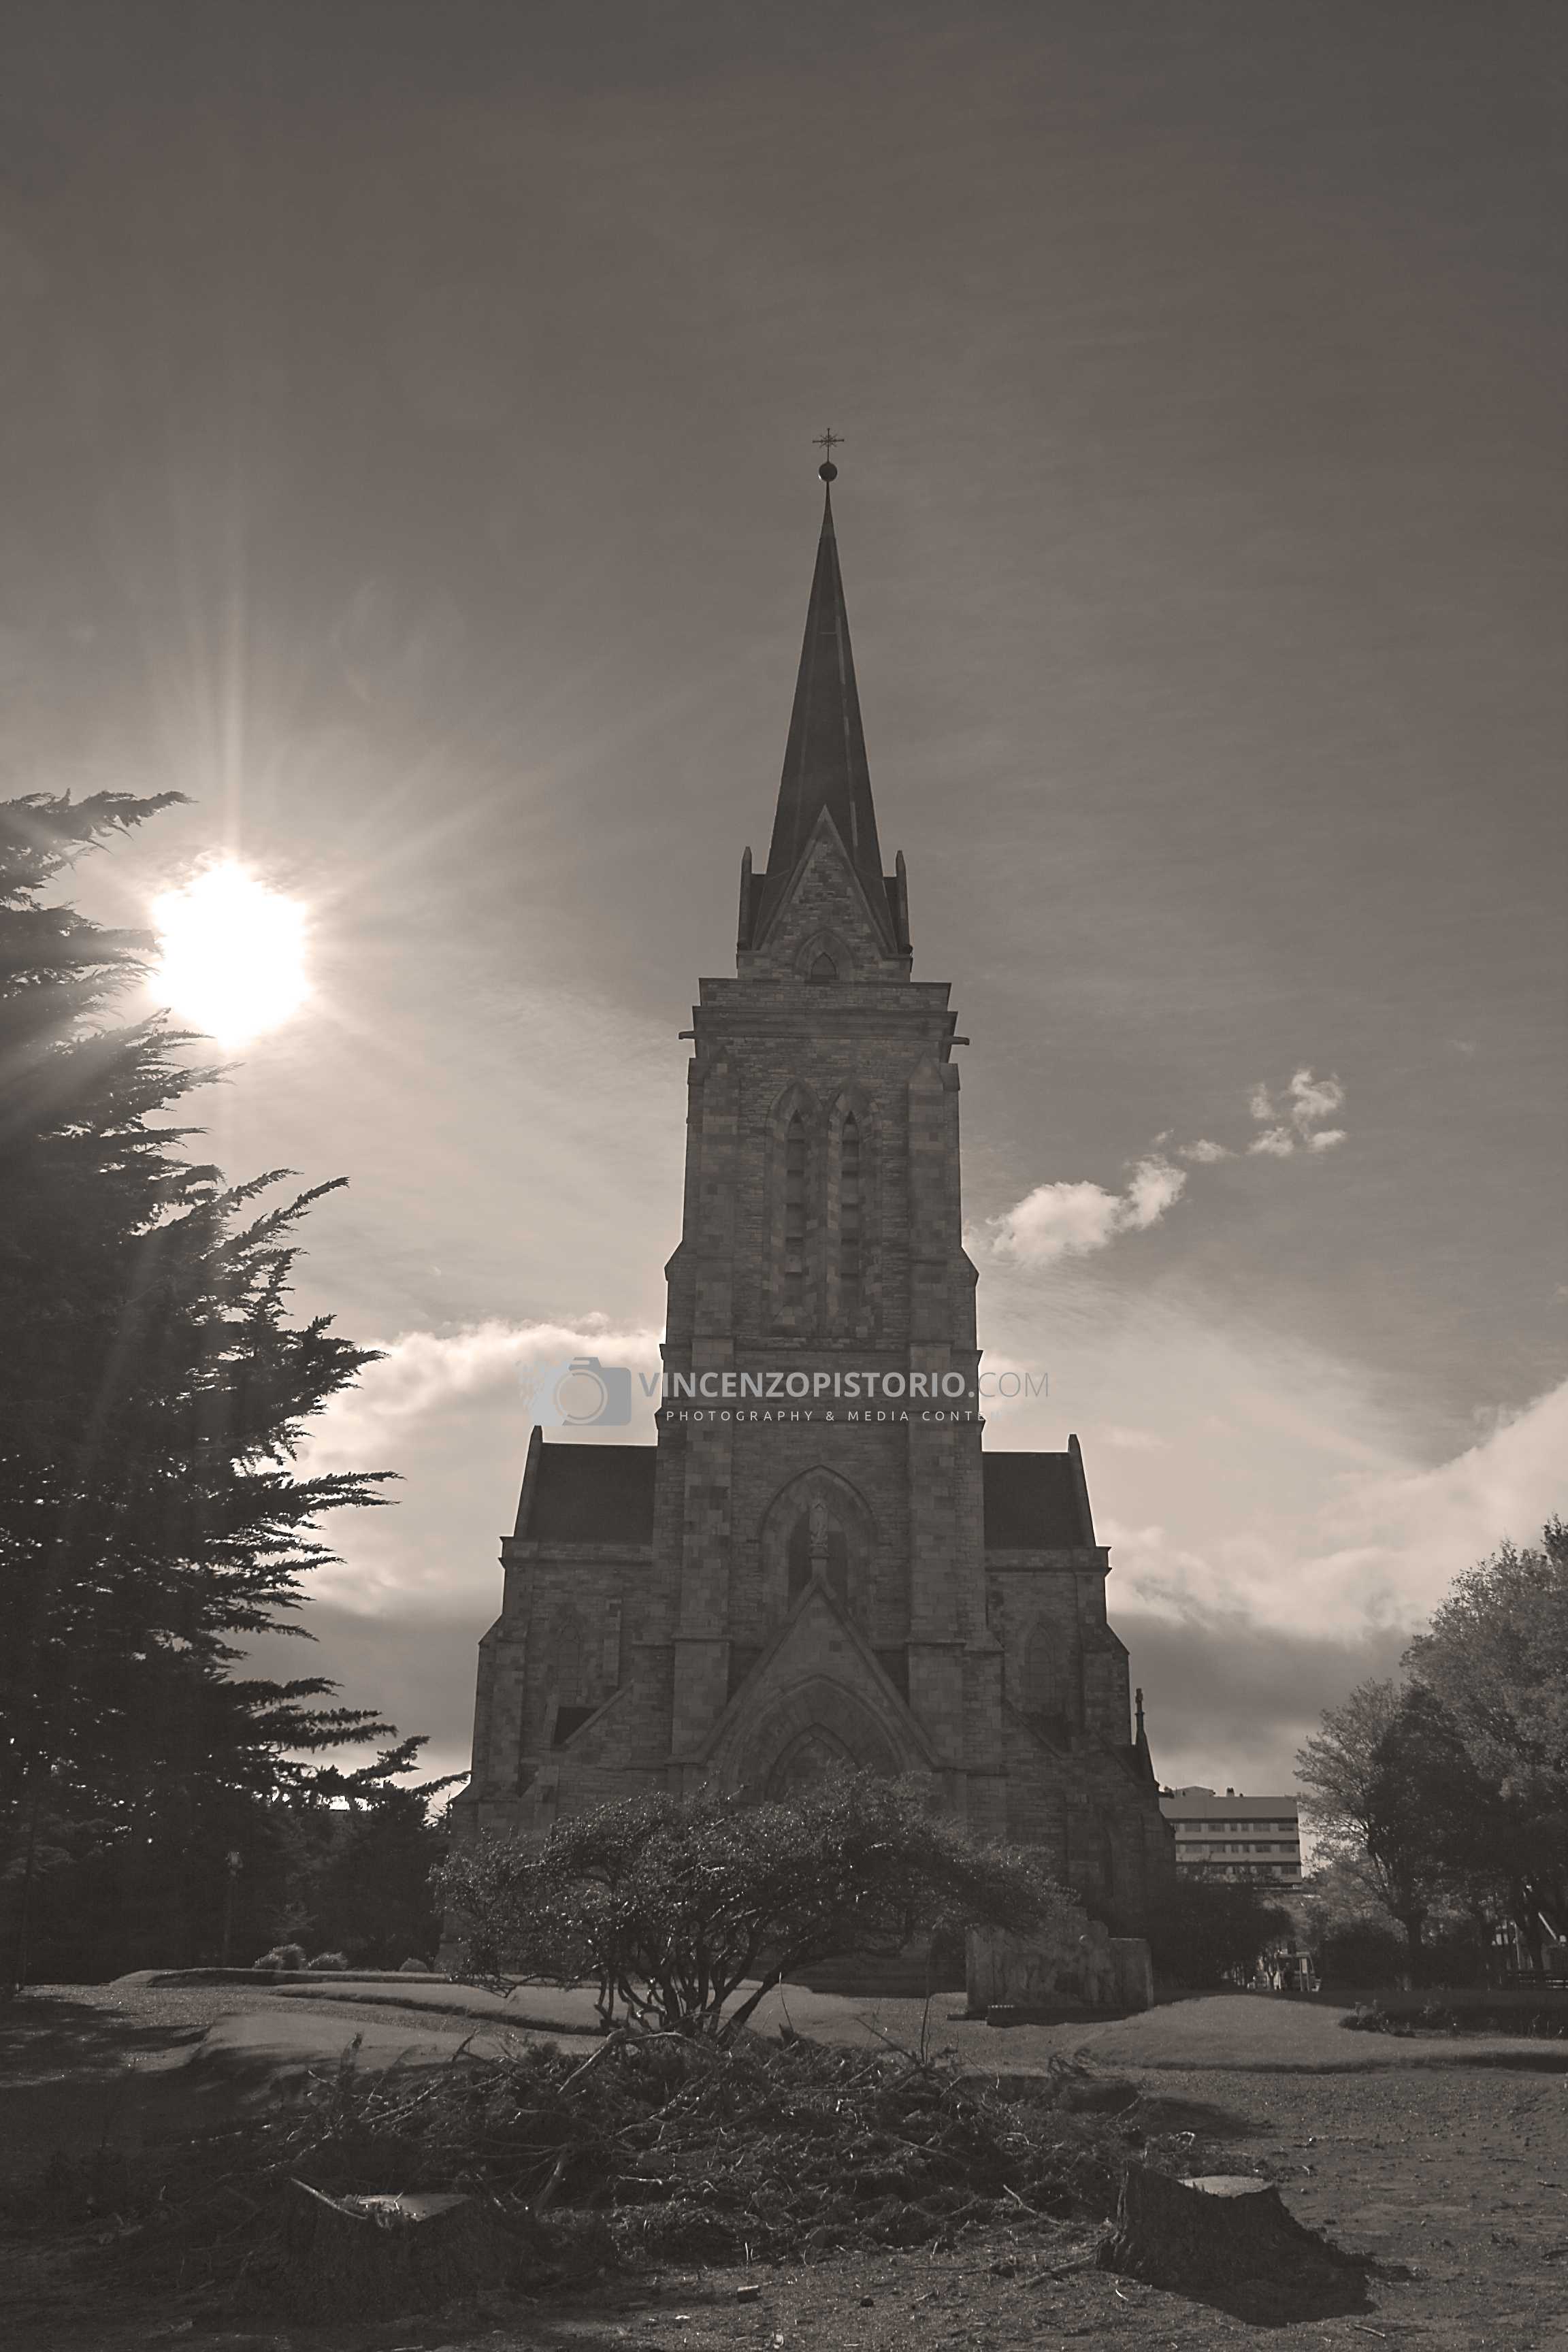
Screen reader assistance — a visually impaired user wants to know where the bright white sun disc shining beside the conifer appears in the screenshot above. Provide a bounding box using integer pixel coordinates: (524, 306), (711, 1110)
(153, 861), (308, 1044)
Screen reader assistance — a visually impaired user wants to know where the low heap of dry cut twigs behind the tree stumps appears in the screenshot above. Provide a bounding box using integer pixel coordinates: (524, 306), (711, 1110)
(101, 2034), (1147, 2296)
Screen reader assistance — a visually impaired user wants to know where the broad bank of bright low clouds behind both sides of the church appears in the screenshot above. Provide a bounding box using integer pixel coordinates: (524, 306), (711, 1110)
(252, 1279), (1568, 1790)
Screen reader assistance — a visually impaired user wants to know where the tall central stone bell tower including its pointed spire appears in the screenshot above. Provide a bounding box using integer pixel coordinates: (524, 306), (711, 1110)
(656, 463), (1002, 1830)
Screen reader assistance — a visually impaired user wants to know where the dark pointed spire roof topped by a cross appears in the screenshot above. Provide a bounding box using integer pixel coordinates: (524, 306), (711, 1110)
(764, 482), (886, 915)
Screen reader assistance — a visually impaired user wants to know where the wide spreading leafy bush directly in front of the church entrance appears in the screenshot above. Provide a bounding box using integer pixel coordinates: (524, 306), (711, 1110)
(442, 1774), (1070, 2037)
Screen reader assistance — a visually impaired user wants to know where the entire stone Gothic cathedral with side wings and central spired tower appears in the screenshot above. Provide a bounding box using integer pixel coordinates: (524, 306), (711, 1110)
(456, 456), (1173, 1931)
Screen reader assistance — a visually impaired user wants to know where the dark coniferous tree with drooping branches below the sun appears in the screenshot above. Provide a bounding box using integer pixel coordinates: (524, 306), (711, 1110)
(0, 793), (419, 1966)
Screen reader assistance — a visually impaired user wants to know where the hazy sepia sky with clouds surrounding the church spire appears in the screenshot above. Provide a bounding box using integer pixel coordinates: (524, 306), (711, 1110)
(0, 0), (1568, 1790)
